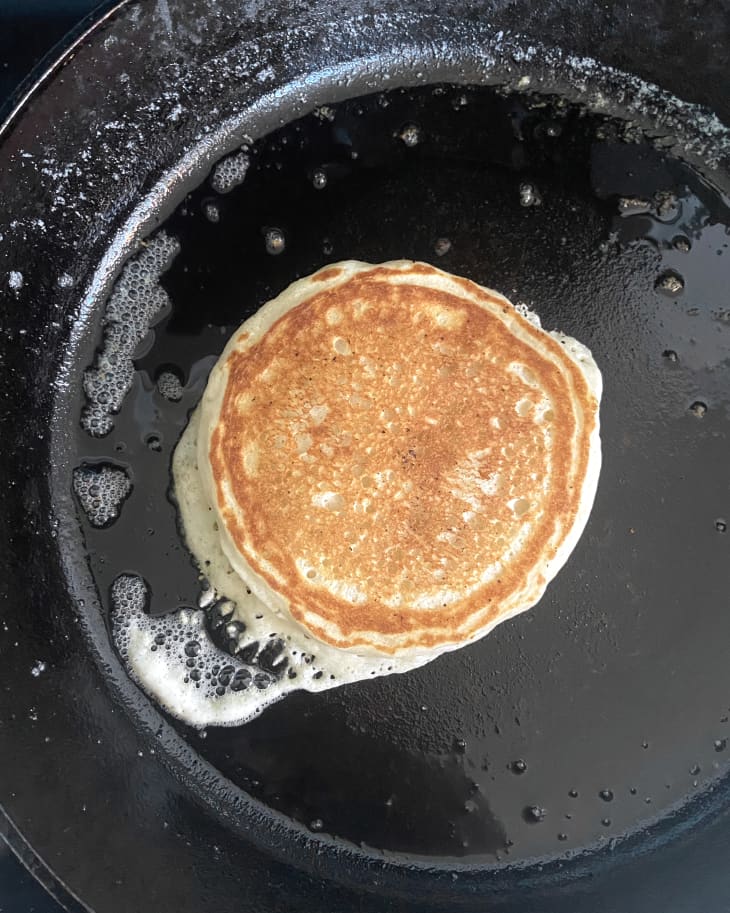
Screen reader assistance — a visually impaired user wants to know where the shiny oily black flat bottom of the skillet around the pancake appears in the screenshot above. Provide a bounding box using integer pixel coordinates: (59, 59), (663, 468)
(72, 87), (730, 862)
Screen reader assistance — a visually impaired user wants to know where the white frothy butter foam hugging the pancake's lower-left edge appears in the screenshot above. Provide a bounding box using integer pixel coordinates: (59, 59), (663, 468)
(112, 410), (429, 727)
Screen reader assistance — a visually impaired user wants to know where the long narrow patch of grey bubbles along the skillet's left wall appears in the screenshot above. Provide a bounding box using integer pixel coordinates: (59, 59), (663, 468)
(81, 231), (180, 437)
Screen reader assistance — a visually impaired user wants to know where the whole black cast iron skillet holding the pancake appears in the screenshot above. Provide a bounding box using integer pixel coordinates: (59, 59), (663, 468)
(0, 0), (730, 913)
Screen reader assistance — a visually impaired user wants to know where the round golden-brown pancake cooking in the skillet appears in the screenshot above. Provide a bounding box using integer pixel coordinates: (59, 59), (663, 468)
(186, 261), (601, 660)
